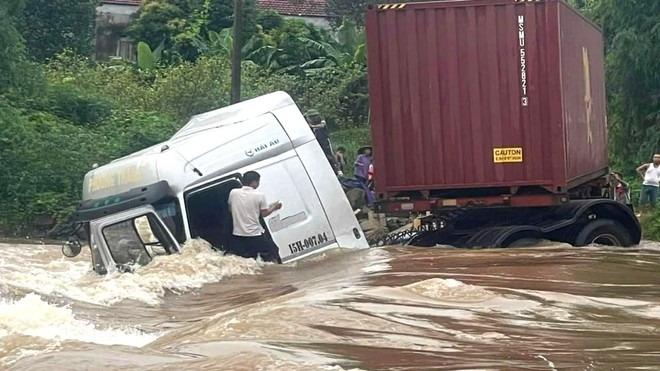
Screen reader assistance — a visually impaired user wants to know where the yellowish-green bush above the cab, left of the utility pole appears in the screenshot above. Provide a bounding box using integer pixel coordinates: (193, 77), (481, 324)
(47, 54), (235, 124)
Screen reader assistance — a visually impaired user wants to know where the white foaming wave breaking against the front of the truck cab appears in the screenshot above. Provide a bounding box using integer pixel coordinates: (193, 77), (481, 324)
(0, 240), (268, 305)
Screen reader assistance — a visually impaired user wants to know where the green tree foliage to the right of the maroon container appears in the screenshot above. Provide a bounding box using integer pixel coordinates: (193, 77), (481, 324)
(573, 0), (660, 169)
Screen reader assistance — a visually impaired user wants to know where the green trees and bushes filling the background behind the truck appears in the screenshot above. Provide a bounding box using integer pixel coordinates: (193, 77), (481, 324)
(0, 0), (660, 238)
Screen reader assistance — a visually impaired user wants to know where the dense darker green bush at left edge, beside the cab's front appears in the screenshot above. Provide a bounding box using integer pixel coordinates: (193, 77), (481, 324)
(0, 104), (176, 235)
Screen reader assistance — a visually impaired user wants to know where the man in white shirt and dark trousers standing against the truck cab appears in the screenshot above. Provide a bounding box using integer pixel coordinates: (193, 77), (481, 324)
(229, 171), (282, 263)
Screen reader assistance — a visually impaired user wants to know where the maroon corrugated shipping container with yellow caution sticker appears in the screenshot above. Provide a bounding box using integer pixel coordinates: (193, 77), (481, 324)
(366, 0), (607, 198)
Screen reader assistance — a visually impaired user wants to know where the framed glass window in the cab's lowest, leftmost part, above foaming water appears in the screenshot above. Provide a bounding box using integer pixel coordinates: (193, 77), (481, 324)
(102, 214), (172, 266)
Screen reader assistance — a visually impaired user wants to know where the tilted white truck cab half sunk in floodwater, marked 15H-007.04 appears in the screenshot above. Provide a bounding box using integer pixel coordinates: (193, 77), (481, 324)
(63, 92), (369, 274)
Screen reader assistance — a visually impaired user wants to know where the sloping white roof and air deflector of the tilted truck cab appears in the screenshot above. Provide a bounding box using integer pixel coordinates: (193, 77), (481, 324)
(82, 92), (315, 202)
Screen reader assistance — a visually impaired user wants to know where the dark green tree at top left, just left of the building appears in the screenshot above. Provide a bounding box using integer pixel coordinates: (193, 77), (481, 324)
(21, 0), (98, 61)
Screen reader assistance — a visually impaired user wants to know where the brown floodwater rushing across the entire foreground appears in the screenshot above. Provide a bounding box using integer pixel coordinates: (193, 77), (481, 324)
(0, 242), (660, 371)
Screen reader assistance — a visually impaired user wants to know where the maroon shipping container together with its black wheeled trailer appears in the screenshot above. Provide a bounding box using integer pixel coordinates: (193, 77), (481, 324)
(366, 0), (641, 247)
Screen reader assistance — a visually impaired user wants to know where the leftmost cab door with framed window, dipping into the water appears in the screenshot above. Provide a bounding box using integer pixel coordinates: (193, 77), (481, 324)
(90, 206), (180, 274)
